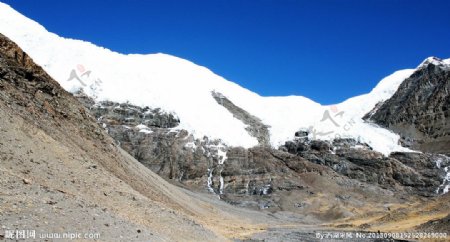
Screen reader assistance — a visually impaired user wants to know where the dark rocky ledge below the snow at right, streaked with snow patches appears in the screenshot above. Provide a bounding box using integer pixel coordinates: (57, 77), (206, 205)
(280, 133), (449, 196)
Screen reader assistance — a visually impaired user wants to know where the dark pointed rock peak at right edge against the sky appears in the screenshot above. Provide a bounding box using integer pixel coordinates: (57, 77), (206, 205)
(364, 58), (450, 154)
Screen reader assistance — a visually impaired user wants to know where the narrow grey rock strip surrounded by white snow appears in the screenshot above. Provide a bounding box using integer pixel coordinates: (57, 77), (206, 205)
(212, 92), (270, 146)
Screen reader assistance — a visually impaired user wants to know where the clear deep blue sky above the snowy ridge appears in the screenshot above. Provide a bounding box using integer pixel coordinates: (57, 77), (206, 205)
(0, 0), (450, 104)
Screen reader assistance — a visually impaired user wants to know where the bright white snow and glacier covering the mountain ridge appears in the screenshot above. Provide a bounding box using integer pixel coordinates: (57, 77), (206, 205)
(0, 3), (420, 154)
